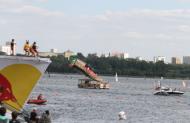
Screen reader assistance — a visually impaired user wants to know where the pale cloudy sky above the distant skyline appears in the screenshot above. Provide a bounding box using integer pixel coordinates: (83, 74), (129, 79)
(0, 0), (190, 60)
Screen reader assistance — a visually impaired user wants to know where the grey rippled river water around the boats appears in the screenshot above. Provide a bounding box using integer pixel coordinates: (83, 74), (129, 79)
(25, 74), (190, 123)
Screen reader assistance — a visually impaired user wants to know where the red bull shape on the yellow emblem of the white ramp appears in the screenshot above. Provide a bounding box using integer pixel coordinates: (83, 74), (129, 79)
(0, 74), (16, 102)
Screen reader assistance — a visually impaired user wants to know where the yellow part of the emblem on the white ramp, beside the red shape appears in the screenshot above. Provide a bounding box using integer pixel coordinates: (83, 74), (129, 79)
(0, 64), (42, 111)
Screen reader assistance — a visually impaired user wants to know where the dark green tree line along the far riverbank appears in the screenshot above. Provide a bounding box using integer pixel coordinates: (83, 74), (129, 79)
(48, 53), (190, 78)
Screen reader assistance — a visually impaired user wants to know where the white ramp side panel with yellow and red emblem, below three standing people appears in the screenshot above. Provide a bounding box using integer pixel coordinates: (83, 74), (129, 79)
(0, 56), (51, 119)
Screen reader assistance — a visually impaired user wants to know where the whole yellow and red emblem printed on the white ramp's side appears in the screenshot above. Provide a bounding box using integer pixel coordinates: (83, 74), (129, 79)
(0, 61), (42, 110)
